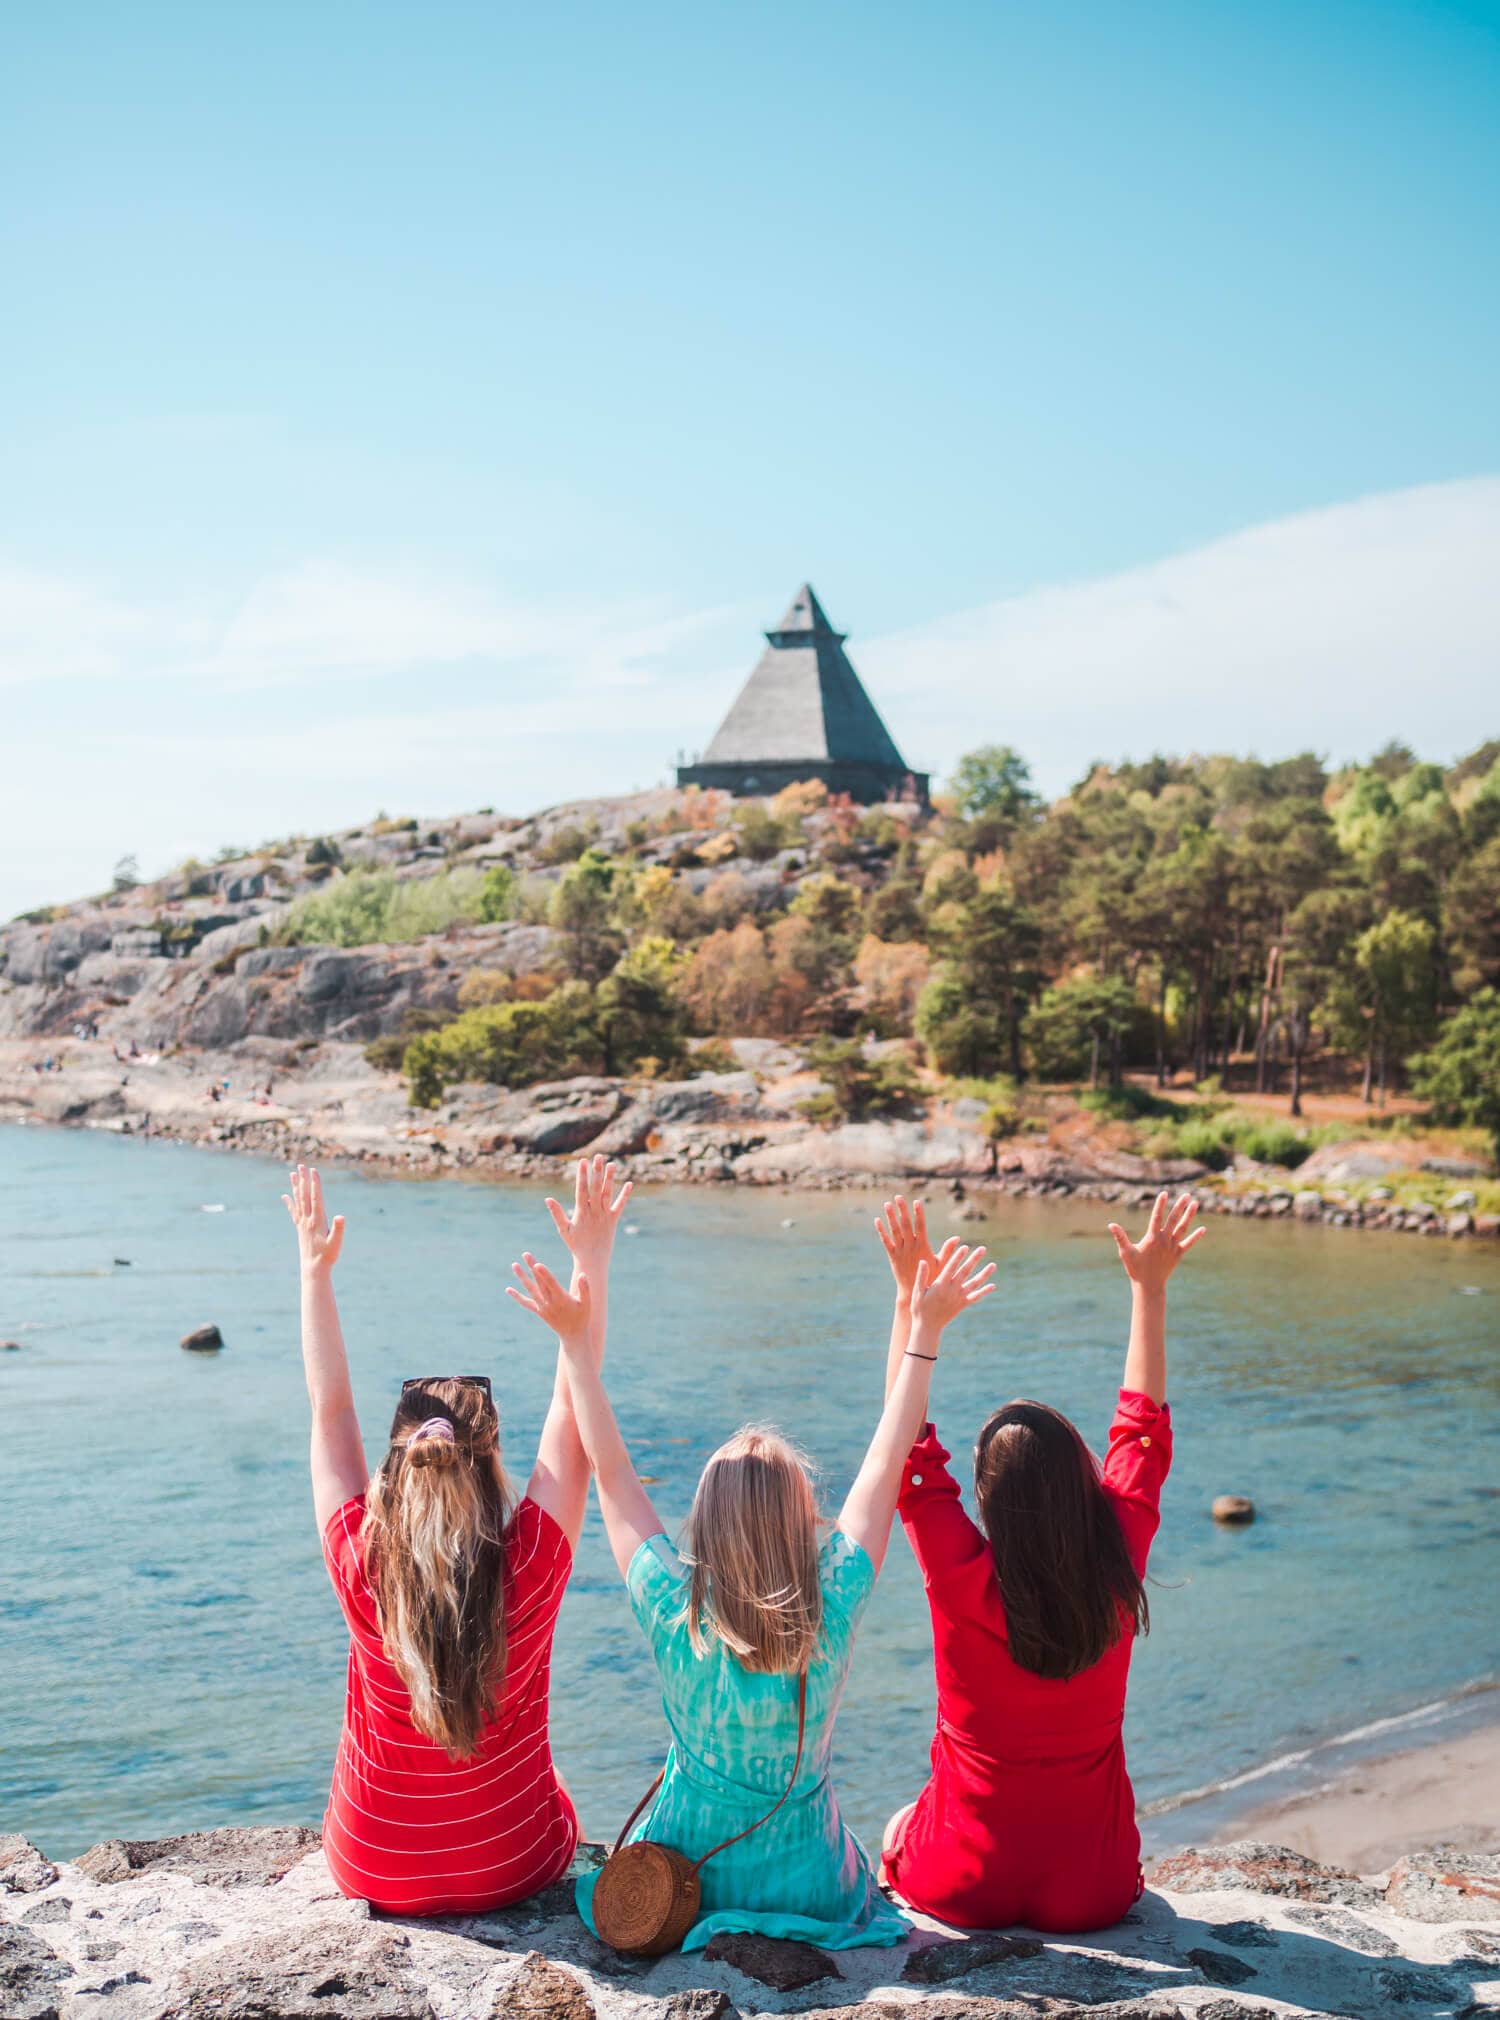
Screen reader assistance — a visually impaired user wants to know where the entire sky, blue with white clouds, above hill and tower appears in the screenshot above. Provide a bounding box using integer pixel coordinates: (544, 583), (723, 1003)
(0, 0), (1500, 913)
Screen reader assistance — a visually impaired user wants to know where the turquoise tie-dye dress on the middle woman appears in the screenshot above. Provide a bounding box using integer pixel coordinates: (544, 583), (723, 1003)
(577, 1529), (908, 1949)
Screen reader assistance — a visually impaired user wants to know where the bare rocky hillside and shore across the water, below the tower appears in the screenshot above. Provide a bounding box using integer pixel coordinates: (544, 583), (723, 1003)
(0, 792), (1500, 1236)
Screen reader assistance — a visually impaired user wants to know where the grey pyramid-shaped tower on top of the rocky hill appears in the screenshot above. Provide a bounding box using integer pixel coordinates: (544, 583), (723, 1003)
(676, 582), (927, 804)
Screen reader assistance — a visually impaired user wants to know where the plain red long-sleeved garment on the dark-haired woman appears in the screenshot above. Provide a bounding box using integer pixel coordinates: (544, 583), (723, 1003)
(886, 1390), (1171, 1933)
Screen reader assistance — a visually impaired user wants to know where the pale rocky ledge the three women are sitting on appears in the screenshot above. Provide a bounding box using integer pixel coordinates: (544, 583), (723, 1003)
(0, 1828), (1500, 2020)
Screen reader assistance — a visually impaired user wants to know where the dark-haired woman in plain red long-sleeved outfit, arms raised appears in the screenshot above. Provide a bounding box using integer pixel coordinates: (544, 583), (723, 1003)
(876, 1192), (1203, 1933)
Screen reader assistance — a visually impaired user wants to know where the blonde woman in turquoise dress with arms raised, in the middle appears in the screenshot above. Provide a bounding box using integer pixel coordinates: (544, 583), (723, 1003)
(511, 1202), (993, 1949)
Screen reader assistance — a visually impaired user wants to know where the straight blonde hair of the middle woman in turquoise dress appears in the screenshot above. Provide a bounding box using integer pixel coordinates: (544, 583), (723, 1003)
(682, 1424), (824, 1675)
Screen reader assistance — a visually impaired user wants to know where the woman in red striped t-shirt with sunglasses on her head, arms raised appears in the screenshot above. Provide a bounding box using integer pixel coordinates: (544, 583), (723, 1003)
(287, 1157), (630, 1915)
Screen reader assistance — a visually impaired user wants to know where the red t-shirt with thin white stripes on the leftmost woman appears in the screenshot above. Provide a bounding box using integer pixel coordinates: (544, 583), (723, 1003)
(323, 1497), (577, 1915)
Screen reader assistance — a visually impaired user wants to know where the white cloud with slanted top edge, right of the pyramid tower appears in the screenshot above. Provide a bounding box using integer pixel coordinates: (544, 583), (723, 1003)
(854, 477), (1500, 792)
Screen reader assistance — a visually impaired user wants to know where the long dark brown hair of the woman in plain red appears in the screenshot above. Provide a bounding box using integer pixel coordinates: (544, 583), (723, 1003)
(973, 1402), (1151, 1679)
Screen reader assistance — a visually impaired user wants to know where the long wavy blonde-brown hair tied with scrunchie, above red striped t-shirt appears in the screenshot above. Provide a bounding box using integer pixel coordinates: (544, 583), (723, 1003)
(361, 1382), (511, 1759)
